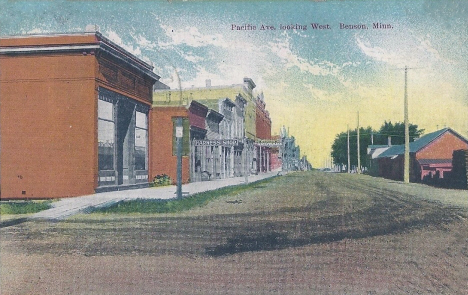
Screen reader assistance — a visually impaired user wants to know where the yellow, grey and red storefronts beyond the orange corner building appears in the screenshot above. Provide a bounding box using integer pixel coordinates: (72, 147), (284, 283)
(153, 78), (281, 182)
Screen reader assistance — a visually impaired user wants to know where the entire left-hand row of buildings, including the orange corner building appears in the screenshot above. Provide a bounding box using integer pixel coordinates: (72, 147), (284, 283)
(0, 31), (304, 199)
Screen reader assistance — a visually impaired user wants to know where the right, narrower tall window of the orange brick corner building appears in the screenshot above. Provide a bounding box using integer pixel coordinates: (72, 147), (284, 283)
(135, 111), (148, 170)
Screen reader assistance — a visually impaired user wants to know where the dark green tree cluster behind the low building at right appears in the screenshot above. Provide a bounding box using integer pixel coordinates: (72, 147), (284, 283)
(331, 121), (424, 167)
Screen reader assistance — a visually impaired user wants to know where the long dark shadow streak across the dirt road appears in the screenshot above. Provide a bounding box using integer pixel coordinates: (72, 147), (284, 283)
(205, 199), (462, 257)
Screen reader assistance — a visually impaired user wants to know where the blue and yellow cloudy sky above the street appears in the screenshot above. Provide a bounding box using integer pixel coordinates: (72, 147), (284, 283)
(0, 0), (468, 167)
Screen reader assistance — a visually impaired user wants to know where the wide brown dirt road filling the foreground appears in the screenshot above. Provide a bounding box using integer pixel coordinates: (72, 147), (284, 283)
(0, 172), (468, 294)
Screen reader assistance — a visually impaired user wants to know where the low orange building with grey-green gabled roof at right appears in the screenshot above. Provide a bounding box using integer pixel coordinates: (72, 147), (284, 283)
(373, 128), (468, 182)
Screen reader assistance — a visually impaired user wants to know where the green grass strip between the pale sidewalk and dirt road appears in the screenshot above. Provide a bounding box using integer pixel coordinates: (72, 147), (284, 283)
(93, 177), (275, 213)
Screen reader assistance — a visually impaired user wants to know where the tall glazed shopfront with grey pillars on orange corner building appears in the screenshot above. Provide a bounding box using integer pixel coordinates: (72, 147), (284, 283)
(98, 87), (149, 187)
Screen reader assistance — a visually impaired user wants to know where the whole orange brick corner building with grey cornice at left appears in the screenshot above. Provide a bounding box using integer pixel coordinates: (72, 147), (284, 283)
(0, 31), (159, 199)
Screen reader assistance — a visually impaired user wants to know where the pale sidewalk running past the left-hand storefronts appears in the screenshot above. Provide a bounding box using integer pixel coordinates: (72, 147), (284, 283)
(29, 171), (278, 220)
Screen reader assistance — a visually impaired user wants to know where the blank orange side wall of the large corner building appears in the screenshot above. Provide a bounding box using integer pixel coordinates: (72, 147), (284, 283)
(0, 54), (97, 199)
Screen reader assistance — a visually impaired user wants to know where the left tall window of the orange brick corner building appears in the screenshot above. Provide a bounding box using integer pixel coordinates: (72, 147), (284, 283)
(98, 100), (115, 170)
